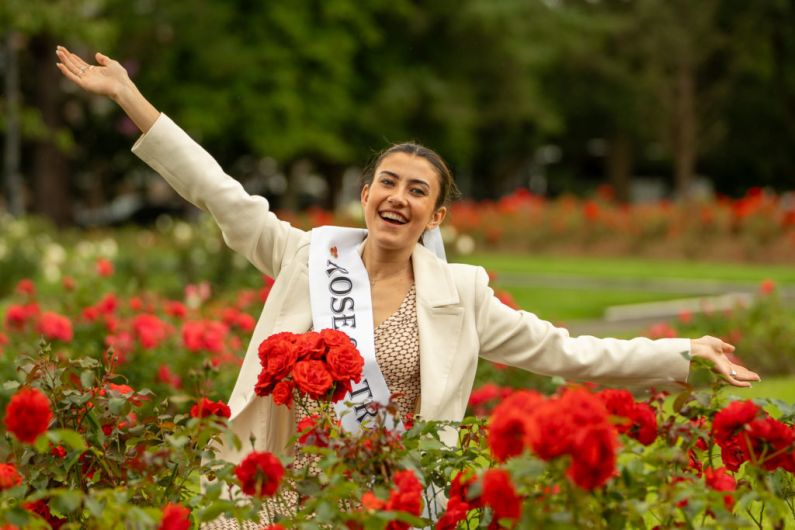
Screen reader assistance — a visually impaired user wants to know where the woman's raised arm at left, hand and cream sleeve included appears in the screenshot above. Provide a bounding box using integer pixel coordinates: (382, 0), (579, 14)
(56, 46), (307, 277)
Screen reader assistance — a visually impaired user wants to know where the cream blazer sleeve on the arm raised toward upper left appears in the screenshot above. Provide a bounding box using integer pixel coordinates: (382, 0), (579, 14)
(132, 114), (307, 277)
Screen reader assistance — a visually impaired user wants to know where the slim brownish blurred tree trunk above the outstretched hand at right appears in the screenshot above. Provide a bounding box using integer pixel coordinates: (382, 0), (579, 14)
(673, 60), (696, 199)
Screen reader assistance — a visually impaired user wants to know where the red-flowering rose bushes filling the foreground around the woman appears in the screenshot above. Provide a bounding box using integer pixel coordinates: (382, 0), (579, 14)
(0, 219), (795, 529)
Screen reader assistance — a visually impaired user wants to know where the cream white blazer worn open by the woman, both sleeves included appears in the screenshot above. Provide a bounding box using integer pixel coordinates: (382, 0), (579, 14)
(133, 114), (690, 462)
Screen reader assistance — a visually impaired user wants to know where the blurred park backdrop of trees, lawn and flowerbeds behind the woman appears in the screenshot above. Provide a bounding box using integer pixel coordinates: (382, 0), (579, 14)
(0, 0), (795, 400)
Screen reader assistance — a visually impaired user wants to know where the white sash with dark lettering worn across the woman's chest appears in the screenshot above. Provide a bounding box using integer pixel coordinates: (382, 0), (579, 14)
(309, 226), (444, 432)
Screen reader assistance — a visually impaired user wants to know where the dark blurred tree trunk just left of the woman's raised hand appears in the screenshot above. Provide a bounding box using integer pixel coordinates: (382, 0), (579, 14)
(31, 35), (72, 226)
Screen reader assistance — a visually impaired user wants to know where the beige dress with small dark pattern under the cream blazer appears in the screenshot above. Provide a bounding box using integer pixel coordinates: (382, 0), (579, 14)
(202, 284), (420, 530)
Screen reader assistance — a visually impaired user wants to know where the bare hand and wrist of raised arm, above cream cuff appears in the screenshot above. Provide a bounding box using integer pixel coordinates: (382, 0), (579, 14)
(55, 46), (160, 133)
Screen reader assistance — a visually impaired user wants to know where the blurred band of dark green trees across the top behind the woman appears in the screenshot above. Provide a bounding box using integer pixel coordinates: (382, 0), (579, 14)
(0, 0), (795, 225)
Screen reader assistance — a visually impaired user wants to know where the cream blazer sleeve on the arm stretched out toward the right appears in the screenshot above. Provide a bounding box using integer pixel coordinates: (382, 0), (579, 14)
(475, 268), (690, 386)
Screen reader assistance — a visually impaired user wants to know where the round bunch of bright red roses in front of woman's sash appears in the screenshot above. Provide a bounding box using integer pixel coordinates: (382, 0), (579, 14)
(254, 329), (364, 406)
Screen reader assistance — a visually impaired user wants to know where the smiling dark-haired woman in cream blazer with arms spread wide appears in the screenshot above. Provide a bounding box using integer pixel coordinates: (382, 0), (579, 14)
(56, 43), (759, 506)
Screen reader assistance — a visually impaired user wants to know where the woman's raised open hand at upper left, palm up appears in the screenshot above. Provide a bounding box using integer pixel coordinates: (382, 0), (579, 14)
(55, 46), (132, 100)
